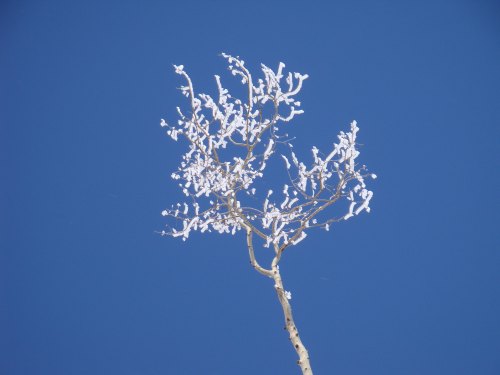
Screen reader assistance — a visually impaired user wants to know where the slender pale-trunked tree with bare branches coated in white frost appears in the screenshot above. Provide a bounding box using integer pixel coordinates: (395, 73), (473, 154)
(161, 54), (376, 374)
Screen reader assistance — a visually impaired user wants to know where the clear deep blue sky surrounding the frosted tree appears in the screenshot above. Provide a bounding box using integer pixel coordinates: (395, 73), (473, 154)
(0, 0), (500, 375)
